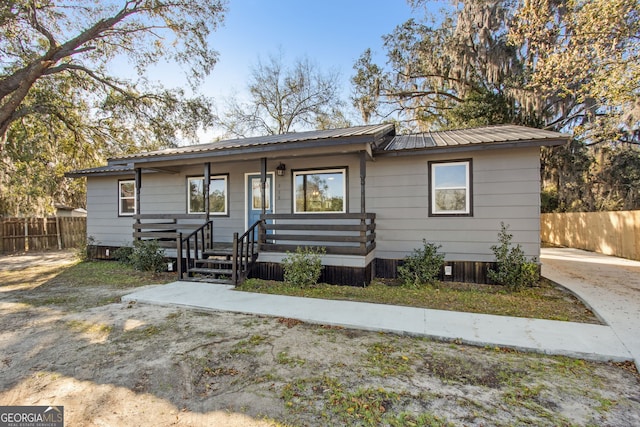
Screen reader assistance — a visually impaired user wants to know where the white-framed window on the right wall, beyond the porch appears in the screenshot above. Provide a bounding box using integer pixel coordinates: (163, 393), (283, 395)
(429, 160), (473, 216)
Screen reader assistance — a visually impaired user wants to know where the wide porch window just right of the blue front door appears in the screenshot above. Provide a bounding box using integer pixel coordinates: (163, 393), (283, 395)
(293, 169), (347, 213)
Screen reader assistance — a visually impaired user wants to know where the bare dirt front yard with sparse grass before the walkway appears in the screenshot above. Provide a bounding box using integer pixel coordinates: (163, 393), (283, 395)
(0, 254), (640, 426)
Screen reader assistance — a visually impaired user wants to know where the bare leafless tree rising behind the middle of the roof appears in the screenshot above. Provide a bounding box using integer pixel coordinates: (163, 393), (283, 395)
(217, 54), (349, 137)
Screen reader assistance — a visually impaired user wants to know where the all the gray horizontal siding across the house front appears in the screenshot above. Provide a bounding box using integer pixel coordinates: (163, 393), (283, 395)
(87, 147), (540, 262)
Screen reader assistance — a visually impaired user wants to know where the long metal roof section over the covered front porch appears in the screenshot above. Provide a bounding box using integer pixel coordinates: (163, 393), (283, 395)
(112, 124), (395, 164)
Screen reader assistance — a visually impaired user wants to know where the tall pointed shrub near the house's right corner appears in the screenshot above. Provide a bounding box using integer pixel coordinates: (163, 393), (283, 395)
(487, 222), (540, 291)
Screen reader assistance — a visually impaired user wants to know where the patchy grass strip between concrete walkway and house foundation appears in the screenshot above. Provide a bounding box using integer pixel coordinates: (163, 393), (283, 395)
(236, 279), (600, 323)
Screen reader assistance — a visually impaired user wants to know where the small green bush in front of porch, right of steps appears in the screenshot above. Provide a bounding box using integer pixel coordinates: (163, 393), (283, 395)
(282, 246), (326, 287)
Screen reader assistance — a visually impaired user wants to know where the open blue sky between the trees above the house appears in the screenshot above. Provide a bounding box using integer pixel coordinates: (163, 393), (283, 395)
(149, 0), (421, 134)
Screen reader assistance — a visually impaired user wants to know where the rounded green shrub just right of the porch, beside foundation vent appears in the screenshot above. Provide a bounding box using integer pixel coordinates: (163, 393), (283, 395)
(398, 239), (444, 287)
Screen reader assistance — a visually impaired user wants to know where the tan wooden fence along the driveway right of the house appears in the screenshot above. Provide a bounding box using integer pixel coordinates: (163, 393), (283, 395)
(540, 210), (640, 260)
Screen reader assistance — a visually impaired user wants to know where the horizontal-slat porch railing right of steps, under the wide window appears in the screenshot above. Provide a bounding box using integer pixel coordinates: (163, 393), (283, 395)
(259, 213), (376, 256)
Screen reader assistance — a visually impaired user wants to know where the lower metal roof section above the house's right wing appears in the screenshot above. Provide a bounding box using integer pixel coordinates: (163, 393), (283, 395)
(382, 125), (570, 152)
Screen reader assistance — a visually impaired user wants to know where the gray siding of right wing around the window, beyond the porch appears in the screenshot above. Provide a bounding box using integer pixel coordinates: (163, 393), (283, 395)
(367, 147), (540, 262)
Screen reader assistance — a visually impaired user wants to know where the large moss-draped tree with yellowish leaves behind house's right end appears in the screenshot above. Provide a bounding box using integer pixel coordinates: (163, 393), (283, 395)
(352, 0), (640, 142)
